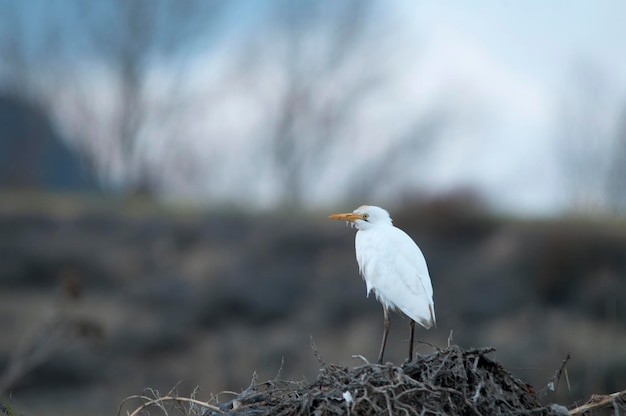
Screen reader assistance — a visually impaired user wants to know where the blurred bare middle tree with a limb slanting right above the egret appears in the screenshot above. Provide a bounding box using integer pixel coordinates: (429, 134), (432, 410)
(236, 0), (452, 207)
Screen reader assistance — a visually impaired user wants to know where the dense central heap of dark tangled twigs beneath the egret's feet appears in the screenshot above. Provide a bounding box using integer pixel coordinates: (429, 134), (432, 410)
(204, 344), (557, 416)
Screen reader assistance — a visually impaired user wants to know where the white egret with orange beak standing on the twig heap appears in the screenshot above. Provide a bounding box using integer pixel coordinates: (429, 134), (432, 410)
(328, 205), (436, 364)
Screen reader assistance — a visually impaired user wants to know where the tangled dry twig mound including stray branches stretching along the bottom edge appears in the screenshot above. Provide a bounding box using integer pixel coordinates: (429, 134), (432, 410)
(118, 345), (626, 416)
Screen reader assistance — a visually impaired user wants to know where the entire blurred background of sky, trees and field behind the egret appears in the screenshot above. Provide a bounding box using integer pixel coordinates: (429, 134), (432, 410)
(0, 0), (626, 415)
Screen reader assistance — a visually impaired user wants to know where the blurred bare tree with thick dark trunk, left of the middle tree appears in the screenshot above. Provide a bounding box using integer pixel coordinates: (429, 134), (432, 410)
(0, 0), (224, 193)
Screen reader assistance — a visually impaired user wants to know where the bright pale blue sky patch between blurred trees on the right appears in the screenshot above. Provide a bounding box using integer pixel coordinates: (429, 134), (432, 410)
(380, 0), (626, 214)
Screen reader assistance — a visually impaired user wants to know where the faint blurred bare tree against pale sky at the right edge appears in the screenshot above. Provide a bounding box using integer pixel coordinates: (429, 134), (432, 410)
(557, 61), (626, 215)
